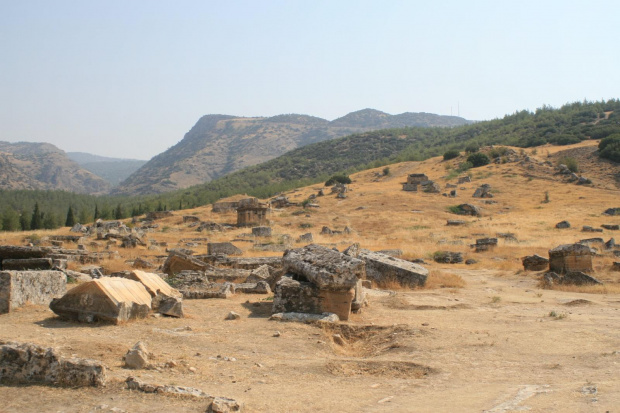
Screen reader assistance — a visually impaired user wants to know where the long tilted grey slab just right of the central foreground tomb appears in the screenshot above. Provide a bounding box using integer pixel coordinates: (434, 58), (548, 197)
(346, 249), (428, 288)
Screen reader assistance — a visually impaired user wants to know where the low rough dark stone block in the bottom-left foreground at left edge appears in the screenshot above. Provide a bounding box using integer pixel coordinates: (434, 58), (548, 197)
(0, 343), (106, 387)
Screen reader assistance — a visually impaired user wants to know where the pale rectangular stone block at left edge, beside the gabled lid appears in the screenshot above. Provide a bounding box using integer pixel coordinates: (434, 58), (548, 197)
(0, 271), (67, 314)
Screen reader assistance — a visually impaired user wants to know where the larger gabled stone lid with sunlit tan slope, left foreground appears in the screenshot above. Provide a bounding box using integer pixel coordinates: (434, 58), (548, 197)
(50, 277), (152, 324)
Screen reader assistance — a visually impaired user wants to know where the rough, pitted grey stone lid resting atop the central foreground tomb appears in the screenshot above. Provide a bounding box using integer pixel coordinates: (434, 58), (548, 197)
(284, 244), (366, 290)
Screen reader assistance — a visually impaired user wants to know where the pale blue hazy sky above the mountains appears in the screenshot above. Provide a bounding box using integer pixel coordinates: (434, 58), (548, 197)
(0, 0), (620, 159)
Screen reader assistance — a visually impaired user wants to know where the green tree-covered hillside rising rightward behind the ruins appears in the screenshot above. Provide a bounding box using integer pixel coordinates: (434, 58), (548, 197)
(0, 99), (620, 229)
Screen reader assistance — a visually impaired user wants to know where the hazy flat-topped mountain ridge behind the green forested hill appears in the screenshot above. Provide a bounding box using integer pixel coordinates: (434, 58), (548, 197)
(113, 109), (470, 195)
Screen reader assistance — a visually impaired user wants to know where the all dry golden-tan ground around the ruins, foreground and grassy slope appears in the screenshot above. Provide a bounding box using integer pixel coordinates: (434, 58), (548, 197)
(0, 142), (620, 412)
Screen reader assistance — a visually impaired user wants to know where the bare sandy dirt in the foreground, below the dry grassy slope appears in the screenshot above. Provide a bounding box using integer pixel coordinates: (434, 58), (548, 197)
(0, 270), (620, 412)
